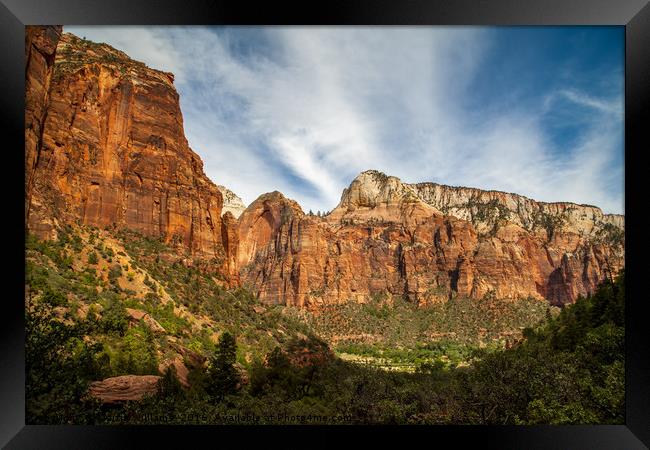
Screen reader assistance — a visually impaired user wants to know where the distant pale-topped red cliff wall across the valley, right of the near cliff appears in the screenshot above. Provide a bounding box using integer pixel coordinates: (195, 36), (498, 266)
(239, 171), (623, 306)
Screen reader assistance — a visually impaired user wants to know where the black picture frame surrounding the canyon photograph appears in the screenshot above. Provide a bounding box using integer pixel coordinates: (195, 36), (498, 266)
(0, 0), (650, 449)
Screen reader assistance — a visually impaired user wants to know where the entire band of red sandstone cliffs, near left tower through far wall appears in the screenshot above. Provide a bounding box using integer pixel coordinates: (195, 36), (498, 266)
(25, 27), (624, 306)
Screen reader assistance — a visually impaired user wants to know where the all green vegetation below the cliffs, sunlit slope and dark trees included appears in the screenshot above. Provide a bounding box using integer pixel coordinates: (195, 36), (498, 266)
(26, 227), (625, 424)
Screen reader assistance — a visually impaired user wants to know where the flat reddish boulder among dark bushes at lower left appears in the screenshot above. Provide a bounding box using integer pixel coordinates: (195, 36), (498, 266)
(88, 375), (160, 403)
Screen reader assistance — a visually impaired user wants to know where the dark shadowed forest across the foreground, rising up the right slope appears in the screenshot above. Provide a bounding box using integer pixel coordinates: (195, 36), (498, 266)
(88, 272), (624, 424)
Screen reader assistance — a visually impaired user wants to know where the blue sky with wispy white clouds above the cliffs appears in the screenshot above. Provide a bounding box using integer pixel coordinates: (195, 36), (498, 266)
(64, 26), (624, 213)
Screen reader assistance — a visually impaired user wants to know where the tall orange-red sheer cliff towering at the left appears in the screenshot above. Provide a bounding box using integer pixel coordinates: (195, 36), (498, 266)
(26, 27), (233, 278)
